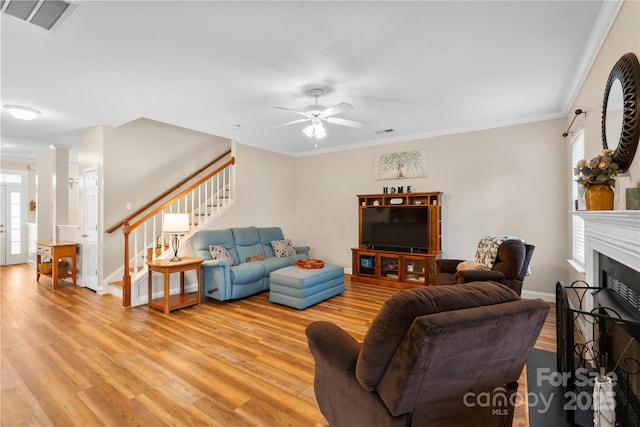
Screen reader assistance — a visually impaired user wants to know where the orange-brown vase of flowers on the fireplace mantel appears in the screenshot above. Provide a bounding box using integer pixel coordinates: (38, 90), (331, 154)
(573, 148), (620, 211)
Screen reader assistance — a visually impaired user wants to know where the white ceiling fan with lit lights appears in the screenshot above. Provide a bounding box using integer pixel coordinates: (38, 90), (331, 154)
(274, 89), (367, 139)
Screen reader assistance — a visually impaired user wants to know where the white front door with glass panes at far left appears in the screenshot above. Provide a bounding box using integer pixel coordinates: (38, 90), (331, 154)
(0, 184), (26, 265)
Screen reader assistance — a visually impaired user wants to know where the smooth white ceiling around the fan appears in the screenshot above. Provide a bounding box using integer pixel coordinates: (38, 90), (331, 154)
(1, 1), (620, 159)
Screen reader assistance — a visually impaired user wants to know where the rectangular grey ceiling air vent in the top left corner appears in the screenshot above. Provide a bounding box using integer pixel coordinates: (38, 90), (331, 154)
(0, 0), (77, 31)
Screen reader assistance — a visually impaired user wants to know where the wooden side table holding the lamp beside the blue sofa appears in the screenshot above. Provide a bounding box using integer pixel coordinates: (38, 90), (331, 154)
(147, 257), (204, 314)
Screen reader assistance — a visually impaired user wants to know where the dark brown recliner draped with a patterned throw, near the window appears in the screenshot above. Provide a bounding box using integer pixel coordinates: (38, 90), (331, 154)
(430, 240), (535, 295)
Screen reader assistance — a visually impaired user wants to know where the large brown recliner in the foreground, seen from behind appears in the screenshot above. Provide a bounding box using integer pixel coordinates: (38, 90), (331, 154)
(307, 282), (549, 427)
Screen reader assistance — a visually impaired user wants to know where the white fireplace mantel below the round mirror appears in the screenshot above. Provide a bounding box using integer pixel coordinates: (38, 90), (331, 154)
(573, 210), (640, 286)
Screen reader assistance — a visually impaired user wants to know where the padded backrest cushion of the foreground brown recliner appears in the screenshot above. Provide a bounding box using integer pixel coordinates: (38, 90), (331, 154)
(356, 282), (519, 391)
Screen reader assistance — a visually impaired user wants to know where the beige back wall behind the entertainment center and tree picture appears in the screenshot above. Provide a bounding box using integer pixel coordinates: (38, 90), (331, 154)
(295, 119), (567, 293)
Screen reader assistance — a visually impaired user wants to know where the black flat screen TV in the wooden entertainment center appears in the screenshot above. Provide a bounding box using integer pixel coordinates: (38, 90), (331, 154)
(360, 206), (429, 252)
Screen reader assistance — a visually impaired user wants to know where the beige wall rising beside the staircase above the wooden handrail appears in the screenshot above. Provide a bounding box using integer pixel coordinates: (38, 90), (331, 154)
(79, 118), (231, 281)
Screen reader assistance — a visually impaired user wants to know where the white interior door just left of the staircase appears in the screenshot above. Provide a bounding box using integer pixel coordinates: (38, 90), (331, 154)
(82, 169), (102, 292)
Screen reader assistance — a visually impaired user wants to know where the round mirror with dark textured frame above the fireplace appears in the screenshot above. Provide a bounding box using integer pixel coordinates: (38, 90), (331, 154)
(602, 53), (640, 172)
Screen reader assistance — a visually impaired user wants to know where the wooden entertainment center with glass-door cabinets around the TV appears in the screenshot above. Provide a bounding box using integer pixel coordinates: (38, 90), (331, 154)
(351, 192), (442, 287)
